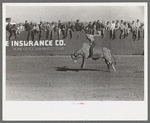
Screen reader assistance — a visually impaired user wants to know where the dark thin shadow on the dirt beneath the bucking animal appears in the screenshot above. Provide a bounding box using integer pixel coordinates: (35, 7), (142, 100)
(55, 66), (109, 72)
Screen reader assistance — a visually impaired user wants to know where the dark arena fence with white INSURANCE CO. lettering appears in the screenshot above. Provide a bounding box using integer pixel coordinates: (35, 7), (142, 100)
(6, 30), (144, 56)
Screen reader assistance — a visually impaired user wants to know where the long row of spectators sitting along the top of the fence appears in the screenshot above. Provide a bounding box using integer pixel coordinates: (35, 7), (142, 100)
(6, 19), (144, 41)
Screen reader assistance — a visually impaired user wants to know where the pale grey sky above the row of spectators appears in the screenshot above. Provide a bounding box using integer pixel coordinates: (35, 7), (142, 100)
(6, 6), (144, 23)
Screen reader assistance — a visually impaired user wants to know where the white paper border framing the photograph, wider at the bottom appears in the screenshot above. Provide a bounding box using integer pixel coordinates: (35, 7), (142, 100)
(2, 2), (148, 121)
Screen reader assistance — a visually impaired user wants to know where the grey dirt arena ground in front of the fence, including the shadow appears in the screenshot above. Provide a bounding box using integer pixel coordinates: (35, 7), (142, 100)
(6, 56), (144, 101)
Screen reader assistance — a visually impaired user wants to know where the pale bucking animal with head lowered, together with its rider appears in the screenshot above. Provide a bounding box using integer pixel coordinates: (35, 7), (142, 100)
(71, 34), (116, 71)
